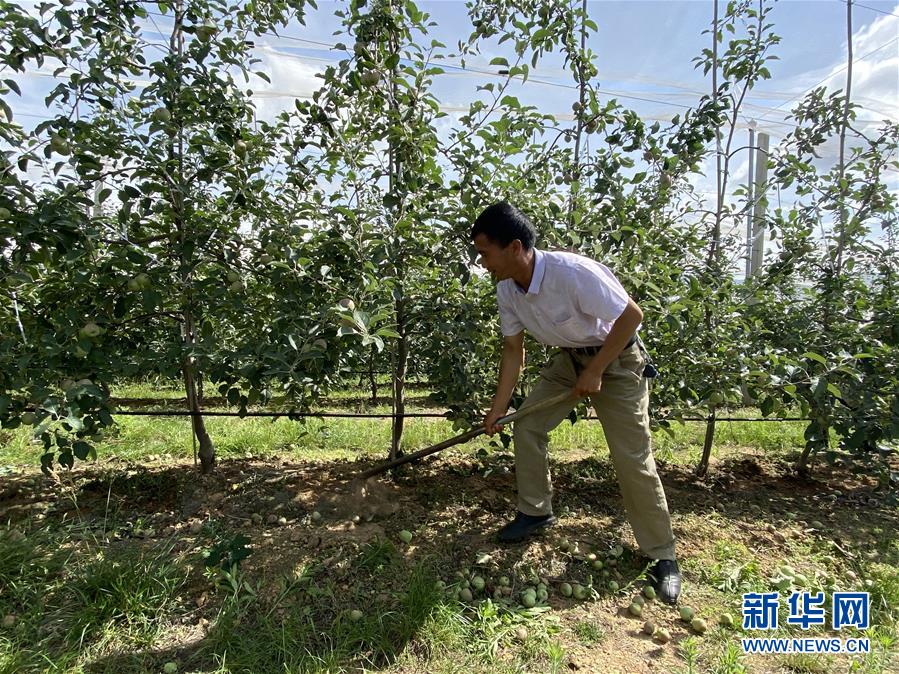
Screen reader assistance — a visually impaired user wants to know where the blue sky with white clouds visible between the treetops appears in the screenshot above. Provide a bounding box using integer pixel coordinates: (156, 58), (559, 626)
(7, 0), (899, 239)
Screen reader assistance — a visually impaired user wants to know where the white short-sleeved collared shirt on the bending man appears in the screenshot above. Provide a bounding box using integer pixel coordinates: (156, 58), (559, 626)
(496, 248), (628, 347)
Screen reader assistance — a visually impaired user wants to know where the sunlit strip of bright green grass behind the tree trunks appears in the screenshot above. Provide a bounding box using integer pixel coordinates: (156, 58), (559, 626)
(0, 384), (804, 465)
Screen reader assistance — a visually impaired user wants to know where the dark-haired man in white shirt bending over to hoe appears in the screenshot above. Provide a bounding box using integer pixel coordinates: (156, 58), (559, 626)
(471, 202), (681, 604)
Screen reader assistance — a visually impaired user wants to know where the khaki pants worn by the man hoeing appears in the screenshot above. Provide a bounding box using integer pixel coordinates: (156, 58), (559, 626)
(513, 344), (674, 559)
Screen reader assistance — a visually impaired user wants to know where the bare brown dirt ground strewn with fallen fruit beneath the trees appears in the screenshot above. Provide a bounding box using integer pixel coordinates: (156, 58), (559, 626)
(0, 440), (899, 674)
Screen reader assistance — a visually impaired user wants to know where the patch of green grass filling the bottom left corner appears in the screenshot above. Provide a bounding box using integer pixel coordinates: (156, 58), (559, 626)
(0, 528), (189, 674)
